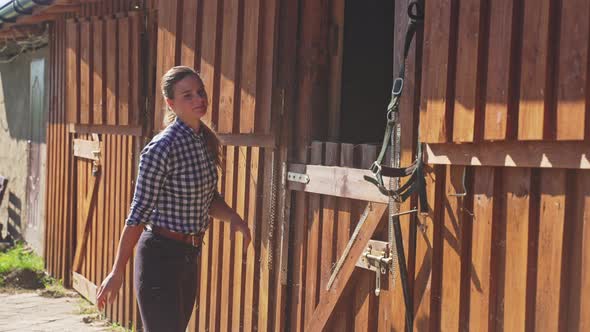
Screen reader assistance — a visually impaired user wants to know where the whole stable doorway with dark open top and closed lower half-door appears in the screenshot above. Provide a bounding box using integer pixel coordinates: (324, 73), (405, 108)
(287, 0), (417, 331)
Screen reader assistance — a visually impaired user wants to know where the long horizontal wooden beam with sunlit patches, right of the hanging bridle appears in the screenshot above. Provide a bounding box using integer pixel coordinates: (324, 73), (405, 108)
(424, 142), (590, 169)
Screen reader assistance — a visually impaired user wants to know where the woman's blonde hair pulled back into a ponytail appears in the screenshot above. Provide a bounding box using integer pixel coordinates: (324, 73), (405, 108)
(160, 66), (221, 168)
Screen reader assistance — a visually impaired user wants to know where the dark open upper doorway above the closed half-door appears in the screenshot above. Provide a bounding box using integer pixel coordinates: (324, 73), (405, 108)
(340, 0), (394, 143)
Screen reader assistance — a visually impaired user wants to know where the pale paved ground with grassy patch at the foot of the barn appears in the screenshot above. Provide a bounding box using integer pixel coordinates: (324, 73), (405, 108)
(0, 244), (126, 332)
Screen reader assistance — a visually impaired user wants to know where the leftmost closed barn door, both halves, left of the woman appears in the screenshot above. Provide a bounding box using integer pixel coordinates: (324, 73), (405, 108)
(66, 12), (148, 306)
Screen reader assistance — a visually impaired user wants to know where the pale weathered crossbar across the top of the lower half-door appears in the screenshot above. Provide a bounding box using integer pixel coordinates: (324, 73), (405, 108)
(288, 164), (388, 203)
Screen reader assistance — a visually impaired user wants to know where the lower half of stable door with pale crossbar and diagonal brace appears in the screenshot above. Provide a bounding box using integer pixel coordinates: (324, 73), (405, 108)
(288, 142), (408, 331)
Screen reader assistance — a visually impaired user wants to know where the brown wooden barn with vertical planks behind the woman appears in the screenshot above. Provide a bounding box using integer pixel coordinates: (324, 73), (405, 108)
(2, 0), (590, 331)
